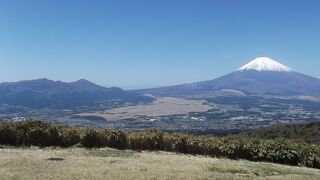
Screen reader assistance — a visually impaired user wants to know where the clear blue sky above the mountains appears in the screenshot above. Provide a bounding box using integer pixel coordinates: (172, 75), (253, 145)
(0, 0), (320, 89)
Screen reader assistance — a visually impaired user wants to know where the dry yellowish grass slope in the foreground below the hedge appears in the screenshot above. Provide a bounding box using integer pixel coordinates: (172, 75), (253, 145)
(0, 147), (320, 180)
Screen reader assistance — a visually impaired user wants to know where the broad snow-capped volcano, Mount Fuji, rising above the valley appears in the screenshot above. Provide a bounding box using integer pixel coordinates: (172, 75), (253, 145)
(141, 57), (320, 98)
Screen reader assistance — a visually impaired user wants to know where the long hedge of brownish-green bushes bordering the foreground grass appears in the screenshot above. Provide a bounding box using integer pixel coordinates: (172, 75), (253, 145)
(0, 121), (320, 168)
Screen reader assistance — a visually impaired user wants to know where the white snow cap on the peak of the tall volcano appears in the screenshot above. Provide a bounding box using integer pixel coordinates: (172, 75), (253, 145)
(237, 57), (293, 72)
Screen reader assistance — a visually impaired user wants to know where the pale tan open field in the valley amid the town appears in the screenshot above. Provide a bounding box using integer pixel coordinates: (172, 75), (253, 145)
(78, 97), (212, 121)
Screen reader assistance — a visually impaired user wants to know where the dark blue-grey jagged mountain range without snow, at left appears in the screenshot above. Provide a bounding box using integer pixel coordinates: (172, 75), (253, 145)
(0, 79), (152, 108)
